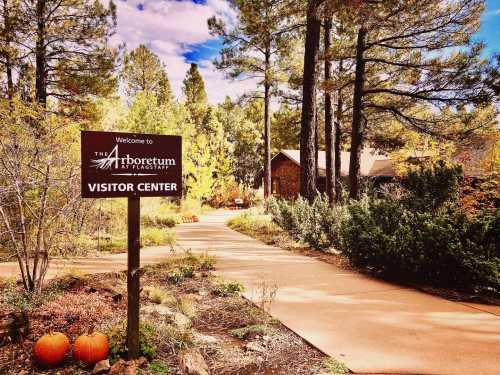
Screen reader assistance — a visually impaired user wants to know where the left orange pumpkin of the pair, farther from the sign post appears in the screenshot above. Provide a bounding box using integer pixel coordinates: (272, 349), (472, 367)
(33, 332), (71, 366)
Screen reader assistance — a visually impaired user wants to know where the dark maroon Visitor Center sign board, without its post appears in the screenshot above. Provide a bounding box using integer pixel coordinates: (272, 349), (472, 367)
(81, 131), (182, 198)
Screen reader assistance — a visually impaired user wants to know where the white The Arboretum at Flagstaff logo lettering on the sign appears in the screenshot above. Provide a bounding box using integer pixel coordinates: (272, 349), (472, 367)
(91, 145), (176, 176)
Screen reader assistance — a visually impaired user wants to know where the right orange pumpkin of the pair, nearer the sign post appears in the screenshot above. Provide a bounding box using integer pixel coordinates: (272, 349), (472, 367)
(73, 332), (109, 365)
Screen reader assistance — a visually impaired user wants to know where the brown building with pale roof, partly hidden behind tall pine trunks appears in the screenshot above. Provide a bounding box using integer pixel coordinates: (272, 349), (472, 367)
(271, 149), (395, 199)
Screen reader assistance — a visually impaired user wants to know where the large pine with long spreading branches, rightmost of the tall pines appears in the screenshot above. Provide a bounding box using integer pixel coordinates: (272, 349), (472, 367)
(340, 0), (494, 198)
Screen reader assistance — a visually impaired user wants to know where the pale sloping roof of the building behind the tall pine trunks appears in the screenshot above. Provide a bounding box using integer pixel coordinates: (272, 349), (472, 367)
(275, 148), (395, 177)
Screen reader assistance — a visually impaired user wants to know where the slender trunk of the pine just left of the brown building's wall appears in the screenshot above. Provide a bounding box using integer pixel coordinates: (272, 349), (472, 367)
(264, 43), (271, 203)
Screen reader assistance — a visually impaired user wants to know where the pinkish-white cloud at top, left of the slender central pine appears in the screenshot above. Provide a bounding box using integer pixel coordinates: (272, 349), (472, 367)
(113, 0), (255, 103)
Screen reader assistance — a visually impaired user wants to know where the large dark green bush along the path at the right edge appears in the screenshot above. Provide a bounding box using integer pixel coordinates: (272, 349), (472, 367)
(342, 198), (500, 291)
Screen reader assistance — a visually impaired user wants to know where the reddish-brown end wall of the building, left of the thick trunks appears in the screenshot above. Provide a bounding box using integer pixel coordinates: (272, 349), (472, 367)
(271, 155), (300, 199)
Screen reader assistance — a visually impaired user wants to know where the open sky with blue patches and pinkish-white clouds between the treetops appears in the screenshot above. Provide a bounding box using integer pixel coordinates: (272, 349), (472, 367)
(114, 0), (500, 103)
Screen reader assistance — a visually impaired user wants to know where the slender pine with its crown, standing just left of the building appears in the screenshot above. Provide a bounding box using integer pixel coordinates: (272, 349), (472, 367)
(208, 0), (295, 203)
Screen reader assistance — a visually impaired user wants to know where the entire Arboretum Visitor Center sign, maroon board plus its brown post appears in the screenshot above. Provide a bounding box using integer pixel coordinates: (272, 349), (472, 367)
(81, 131), (182, 359)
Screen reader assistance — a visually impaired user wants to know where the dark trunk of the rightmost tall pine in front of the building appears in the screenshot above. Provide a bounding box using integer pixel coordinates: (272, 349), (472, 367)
(349, 27), (366, 199)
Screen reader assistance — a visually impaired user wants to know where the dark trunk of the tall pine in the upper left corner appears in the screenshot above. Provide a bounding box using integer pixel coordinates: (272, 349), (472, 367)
(35, 0), (47, 106)
